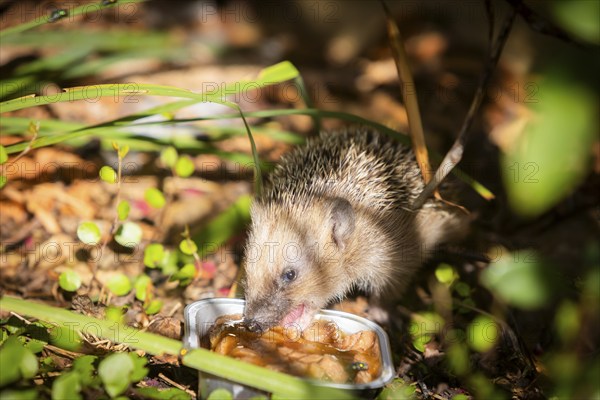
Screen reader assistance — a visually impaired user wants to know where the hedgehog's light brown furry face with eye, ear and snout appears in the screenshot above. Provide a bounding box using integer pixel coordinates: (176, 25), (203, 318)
(244, 198), (355, 329)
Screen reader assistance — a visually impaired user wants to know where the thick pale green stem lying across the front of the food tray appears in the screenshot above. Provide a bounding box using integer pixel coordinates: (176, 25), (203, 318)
(0, 296), (352, 399)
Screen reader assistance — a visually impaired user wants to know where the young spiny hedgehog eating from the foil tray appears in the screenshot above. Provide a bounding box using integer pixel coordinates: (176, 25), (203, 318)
(243, 127), (464, 330)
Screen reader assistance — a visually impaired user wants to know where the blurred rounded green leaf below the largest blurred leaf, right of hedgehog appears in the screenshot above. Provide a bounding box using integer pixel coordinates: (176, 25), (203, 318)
(481, 248), (551, 309)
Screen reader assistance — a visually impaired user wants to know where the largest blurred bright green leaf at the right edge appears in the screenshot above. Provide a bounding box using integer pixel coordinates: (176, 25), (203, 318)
(501, 74), (598, 218)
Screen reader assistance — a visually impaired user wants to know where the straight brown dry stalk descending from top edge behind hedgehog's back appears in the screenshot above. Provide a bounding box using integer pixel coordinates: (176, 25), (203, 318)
(381, 0), (431, 183)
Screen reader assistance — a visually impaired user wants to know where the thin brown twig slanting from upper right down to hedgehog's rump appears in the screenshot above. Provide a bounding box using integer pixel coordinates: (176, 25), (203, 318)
(412, 5), (519, 209)
